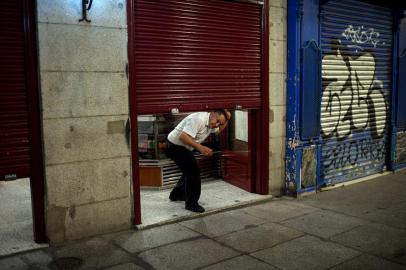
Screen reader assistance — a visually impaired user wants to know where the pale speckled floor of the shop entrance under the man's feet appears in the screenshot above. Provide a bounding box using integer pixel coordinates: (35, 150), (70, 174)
(139, 180), (271, 228)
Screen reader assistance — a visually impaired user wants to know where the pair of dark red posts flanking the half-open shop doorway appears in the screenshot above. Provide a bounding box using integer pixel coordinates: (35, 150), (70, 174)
(127, 0), (269, 224)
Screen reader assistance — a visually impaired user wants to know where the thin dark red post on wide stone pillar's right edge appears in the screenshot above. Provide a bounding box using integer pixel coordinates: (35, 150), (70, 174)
(127, 0), (141, 225)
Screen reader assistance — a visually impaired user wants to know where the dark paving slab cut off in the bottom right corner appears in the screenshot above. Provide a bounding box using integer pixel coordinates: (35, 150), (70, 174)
(329, 254), (406, 270)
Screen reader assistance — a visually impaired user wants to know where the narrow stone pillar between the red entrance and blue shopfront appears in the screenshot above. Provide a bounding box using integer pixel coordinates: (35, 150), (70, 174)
(269, 0), (287, 196)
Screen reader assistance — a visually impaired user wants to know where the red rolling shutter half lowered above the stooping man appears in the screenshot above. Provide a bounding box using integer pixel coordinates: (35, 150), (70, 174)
(132, 0), (262, 114)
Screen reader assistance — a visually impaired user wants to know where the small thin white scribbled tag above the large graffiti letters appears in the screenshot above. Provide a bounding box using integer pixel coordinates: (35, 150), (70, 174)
(341, 25), (379, 48)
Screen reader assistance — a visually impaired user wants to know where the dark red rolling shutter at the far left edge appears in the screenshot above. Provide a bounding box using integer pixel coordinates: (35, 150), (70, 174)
(0, 1), (30, 179)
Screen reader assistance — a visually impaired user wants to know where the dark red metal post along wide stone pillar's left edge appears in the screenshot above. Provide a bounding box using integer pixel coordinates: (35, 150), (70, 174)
(23, 0), (47, 243)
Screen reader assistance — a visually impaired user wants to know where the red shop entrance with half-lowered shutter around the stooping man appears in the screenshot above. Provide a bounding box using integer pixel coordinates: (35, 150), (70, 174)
(128, 0), (269, 224)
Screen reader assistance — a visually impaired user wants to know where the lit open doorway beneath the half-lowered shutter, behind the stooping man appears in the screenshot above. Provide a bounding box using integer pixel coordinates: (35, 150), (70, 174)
(138, 109), (270, 228)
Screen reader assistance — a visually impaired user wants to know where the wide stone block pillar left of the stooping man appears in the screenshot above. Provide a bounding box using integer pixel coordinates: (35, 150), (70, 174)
(37, 0), (132, 243)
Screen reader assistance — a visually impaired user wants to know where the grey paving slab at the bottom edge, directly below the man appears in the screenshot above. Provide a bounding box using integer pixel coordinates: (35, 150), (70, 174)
(139, 239), (239, 270)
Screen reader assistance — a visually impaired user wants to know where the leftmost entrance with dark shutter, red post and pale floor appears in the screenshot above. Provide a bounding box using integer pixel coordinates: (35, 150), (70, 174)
(0, 0), (46, 252)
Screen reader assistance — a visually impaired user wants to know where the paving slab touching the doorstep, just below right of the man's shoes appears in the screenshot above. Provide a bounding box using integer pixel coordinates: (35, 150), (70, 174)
(180, 209), (265, 237)
